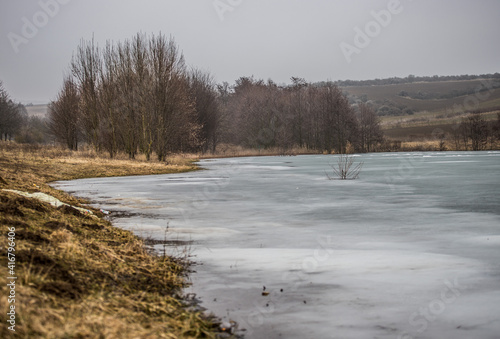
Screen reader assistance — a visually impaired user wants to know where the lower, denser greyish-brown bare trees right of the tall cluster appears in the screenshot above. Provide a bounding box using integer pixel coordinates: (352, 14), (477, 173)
(219, 77), (383, 153)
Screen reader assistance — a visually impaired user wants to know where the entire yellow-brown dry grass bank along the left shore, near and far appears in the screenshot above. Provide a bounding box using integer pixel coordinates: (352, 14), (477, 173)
(0, 143), (221, 338)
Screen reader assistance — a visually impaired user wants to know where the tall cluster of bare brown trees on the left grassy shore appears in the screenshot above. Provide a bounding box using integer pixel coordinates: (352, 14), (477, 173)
(49, 34), (219, 160)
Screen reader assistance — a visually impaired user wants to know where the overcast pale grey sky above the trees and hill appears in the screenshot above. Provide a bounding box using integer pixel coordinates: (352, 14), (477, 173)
(0, 0), (500, 103)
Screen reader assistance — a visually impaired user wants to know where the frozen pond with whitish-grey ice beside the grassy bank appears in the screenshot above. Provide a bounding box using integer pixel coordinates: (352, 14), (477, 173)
(54, 152), (500, 339)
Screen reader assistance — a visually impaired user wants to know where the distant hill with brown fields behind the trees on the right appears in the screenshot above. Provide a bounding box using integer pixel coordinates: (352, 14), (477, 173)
(341, 73), (500, 140)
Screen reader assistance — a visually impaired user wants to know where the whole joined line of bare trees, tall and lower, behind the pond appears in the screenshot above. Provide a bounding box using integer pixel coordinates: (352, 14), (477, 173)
(49, 34), (383, 160)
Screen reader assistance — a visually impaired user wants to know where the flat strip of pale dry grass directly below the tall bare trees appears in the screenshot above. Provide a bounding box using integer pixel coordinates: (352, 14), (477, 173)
(0, 142), (197, 203)
